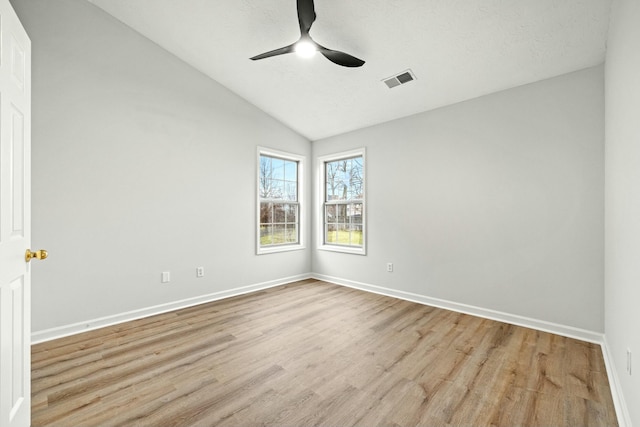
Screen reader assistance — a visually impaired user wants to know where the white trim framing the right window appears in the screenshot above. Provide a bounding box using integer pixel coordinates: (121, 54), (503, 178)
(316, 147), (367, 255)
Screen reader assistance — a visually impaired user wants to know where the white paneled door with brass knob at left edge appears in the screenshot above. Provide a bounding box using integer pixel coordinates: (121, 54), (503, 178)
(0, 0), (31, 427)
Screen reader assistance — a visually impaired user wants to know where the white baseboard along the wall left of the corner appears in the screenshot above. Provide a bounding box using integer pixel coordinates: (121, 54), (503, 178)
(31, 274), (312, 344)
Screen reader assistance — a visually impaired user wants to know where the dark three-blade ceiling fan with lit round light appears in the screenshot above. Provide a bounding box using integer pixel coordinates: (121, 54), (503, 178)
(251, 0), (364, 67)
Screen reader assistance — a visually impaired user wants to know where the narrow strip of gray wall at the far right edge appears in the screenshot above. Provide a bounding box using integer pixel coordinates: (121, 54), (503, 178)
(604, 0), (640, 426)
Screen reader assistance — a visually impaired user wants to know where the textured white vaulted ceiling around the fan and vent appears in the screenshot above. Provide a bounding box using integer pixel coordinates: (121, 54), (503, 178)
(89, 0), (611, 140)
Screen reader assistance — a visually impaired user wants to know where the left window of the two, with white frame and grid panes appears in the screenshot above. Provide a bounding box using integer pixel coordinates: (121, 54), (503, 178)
(257, 148), (304, 254)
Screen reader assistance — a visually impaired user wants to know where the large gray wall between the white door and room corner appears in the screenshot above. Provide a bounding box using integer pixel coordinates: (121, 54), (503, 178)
(13, 0), (311, 332)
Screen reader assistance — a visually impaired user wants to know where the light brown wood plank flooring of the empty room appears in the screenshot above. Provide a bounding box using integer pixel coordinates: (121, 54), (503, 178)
(32, 280), (617, 427)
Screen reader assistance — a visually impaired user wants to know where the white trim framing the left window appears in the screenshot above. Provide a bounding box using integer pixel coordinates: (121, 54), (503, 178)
(255, 147), (307, 255)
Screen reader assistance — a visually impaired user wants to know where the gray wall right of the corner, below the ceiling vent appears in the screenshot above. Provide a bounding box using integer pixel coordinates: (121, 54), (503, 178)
(312, 66), (604, 332)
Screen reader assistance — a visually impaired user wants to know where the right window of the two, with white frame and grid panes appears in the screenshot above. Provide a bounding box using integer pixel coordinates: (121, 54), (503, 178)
(318, 149), (366, 255)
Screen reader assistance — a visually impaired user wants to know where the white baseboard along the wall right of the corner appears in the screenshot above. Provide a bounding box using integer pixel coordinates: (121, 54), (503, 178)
(311, 273), (604, 344)
